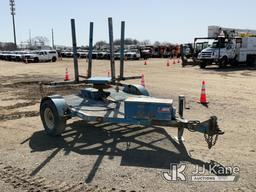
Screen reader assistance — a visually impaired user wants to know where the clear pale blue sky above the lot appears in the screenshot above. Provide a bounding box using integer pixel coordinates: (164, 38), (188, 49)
(0, 0), (256, 46)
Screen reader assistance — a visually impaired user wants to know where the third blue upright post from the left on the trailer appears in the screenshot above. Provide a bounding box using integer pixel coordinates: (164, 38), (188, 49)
(108, 17), (116, 82)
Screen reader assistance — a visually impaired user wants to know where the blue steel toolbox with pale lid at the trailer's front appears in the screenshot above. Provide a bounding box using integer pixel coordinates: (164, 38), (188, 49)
(124, 97), (174, 120)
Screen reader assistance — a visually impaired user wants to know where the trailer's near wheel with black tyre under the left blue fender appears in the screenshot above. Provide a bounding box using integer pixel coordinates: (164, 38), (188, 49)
(40, 100), (66, 136)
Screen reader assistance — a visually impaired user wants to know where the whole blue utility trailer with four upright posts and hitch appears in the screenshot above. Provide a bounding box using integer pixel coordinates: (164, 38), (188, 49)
(40, 18), (224, 149)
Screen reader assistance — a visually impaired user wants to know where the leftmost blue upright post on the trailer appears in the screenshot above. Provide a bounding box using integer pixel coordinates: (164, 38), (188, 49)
(71, 19), (79, 83)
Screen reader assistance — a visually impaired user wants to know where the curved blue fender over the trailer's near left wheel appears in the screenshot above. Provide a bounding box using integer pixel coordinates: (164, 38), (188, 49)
(40, 95), (70, 118)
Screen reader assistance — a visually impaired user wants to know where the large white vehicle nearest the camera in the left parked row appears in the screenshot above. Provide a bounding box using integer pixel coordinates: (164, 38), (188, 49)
(23, 50), (58, 63)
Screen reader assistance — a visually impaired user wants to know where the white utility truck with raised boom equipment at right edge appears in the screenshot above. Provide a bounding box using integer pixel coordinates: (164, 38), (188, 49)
(197, 26), (256, 68)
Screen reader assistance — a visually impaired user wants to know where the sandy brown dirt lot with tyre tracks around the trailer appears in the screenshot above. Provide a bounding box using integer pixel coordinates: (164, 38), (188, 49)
(0, 59), (256, 192)
